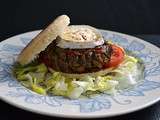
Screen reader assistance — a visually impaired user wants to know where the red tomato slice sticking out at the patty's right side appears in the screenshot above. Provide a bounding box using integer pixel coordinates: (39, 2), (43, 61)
(104, 45), (125, 68)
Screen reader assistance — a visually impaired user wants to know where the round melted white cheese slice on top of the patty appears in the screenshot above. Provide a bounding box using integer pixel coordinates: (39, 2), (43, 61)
(57, 25), (104, 49)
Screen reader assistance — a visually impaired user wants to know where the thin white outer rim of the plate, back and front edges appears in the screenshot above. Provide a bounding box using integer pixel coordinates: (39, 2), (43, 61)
(0, 29), (160, 118)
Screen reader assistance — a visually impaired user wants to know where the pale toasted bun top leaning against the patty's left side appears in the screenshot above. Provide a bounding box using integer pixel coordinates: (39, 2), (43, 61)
(17, 15), (70, 65)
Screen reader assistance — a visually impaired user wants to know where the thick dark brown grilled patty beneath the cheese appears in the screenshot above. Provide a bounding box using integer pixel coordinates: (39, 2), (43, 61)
(38, 40), (112, 74)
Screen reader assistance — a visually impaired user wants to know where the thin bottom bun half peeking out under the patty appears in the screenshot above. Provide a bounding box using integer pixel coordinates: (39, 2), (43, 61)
(49, 68), (114, 78)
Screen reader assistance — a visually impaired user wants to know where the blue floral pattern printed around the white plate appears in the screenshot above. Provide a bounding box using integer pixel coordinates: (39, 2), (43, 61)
(0, 31), (160, 117)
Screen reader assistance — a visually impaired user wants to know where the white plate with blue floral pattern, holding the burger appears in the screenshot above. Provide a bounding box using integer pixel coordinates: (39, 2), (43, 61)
(0, 30), (160, 118)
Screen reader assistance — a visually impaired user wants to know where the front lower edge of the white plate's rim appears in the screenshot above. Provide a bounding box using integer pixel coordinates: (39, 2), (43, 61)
(0, 92), (160, 119)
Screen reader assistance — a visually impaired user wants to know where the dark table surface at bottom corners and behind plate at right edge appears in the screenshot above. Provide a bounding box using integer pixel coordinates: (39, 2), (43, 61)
(0, 35), (160, 120)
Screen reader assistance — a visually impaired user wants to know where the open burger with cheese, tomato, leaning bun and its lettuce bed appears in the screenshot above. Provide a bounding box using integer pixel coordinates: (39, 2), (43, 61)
(14, 15), (139, 99)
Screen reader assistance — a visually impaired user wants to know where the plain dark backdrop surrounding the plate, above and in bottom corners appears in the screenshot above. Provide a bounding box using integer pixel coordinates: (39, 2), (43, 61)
(0, 0), (160, 120)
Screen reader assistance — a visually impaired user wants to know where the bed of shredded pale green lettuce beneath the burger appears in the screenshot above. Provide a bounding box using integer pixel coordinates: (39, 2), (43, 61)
(14, 55), (142, 99)
